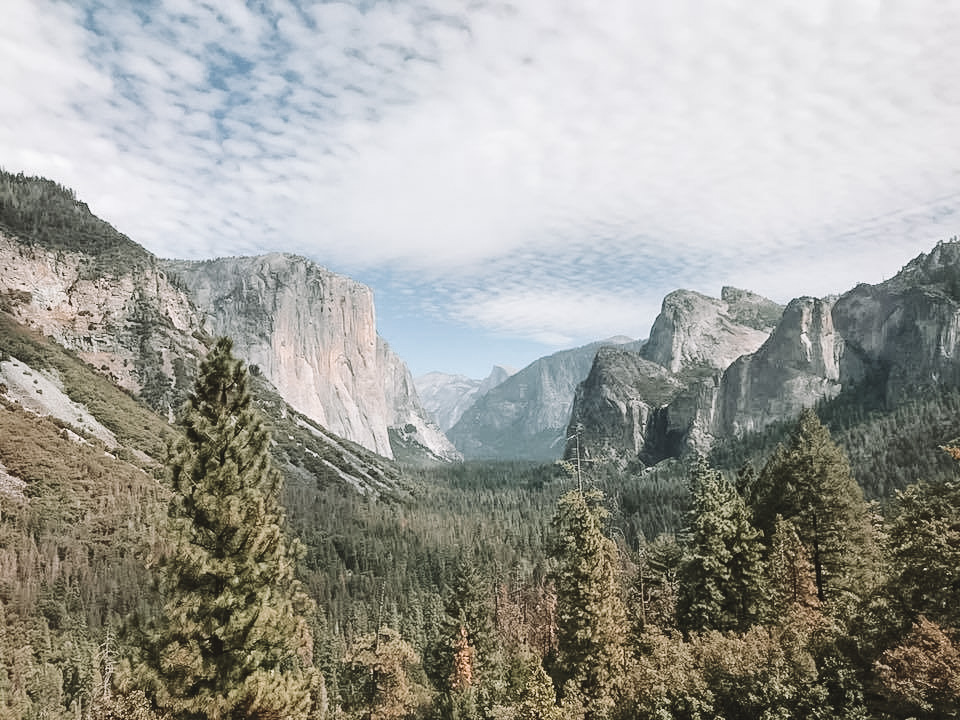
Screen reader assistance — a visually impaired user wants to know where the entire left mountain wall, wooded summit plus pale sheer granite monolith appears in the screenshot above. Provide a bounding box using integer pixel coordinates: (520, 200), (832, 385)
(0, 172), (458, 460)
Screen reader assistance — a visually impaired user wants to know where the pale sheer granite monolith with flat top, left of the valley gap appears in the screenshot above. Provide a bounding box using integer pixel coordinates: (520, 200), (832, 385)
(166, 253), (457, 459)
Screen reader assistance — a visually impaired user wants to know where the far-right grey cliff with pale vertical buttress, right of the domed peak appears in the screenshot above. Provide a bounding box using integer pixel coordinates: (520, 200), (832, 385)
(716, 242), (960, 436)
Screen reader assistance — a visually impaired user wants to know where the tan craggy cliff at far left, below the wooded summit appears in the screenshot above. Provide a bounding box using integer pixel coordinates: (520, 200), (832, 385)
(0, 233), (206, 410)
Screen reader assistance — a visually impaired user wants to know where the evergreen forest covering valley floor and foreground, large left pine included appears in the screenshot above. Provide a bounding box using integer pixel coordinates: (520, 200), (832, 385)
(0, 176), (960, 720)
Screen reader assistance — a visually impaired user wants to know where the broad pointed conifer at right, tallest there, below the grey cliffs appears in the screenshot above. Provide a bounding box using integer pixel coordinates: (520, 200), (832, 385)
(747, 409), (876, 602)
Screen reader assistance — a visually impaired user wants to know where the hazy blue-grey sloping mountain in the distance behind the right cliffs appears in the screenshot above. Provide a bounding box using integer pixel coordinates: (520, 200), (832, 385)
(448, 342), (638, 460)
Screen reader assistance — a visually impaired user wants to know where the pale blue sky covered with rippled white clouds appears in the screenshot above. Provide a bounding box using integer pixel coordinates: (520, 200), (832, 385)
(0, 0), (960, 378)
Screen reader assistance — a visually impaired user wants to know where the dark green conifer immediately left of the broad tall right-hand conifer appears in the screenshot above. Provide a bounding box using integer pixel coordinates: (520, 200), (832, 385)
(677, 457), (763, 632)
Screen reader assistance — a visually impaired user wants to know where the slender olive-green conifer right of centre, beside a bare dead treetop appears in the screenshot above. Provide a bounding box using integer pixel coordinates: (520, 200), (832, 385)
(552, 491), (626, 718)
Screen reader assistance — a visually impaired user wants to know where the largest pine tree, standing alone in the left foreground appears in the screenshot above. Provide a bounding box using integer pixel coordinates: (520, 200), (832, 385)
(144, 338), (322, 720)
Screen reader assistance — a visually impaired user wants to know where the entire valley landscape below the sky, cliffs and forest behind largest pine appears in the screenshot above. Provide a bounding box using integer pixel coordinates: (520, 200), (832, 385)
(0, 173), (960, 720)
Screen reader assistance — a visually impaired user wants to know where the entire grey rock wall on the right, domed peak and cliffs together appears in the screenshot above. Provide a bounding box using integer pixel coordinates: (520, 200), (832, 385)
(567, 241), (960, 462)
